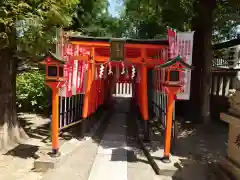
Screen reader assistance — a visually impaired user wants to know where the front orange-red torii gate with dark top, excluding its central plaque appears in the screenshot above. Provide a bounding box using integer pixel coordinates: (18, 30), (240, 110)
(69, 37), (168, 116)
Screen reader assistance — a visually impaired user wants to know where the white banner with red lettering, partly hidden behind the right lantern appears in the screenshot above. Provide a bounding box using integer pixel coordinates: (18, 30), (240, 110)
(177, 32), (194, 100)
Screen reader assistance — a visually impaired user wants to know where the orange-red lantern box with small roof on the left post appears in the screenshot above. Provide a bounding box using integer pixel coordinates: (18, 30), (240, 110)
(41, 52), (65, 82)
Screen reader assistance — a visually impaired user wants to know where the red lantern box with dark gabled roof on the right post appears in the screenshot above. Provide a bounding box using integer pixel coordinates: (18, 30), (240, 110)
(157, 56), (193, 87)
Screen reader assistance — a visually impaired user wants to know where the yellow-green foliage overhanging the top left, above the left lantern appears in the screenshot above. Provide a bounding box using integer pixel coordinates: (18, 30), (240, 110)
(0, 0), (79, 60)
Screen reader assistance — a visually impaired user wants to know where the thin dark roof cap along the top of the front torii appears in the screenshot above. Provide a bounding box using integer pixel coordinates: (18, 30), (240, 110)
(69, 36), (168, 46)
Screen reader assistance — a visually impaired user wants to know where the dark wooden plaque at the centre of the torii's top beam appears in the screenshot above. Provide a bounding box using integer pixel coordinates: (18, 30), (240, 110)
(110, 38), (125, 61)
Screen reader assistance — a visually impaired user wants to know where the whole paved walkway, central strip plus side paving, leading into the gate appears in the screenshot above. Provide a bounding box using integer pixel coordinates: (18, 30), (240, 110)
(42, 100), (165, 180)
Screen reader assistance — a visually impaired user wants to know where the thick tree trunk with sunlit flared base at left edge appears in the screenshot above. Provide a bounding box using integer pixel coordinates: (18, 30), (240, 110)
(0, 47), (27, 150)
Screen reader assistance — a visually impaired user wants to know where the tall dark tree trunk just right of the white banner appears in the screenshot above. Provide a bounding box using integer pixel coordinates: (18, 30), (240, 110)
(191, 0), (216, 123)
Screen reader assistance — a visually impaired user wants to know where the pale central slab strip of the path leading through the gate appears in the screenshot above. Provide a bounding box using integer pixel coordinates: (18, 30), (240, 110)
(88, 114), (127, 180)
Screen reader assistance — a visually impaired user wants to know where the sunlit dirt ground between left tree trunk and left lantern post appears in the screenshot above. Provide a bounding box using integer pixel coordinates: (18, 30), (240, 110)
(0, 113), (49, 180)
